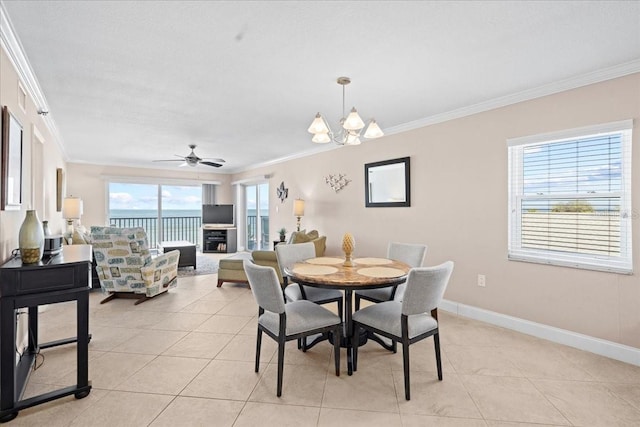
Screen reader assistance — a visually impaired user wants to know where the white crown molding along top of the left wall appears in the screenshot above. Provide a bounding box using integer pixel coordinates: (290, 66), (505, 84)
(0, 0), (68, 161)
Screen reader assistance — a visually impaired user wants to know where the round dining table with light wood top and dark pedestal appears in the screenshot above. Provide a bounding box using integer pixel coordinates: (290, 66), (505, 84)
(284, 257), (411, 375)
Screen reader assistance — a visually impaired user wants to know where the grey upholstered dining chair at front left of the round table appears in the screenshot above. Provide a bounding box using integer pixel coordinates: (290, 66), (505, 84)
(244, 260), (342, 397)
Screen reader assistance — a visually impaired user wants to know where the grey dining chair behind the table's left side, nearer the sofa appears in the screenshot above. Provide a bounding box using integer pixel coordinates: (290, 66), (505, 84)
(276, 242), (343, 319)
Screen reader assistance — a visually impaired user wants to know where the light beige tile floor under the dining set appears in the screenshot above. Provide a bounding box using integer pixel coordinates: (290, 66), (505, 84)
(11, 266), (640, 427)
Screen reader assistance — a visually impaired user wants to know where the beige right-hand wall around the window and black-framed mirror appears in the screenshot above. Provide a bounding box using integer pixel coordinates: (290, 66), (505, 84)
(234, 74), (640, 348)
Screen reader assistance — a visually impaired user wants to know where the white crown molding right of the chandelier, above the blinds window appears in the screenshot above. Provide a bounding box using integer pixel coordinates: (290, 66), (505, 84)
(384, 59), (640, 135)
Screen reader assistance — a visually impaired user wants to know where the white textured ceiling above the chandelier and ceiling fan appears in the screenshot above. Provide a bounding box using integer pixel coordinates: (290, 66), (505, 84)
(2, 1), (640, 172)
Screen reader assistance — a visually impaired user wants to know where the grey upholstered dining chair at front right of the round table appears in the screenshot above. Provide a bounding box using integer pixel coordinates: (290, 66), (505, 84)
(353, 261), (453, 400)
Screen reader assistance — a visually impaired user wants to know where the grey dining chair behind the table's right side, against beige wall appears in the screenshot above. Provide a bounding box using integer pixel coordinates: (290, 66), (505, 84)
(354, 242), (427, 310)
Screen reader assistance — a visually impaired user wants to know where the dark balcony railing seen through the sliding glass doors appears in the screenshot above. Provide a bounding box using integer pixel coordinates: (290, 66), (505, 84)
(109, 215), (269, 250)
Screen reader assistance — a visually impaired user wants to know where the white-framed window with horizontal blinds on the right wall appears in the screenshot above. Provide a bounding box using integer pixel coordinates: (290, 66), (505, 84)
(507, 120), (633, 274)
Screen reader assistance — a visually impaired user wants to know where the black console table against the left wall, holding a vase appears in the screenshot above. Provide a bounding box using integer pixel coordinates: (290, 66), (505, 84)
(0, 245), (91, 423)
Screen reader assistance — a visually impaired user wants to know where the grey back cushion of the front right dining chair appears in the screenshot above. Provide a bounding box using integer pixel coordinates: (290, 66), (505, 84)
(402, 261), (453, 316)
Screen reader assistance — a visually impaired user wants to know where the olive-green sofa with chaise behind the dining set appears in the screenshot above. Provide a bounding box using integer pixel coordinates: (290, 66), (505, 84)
(218, 230), (327, 287)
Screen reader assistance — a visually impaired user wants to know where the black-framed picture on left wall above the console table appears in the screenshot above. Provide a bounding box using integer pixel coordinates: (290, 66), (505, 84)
(0, 105), (22, 210)
